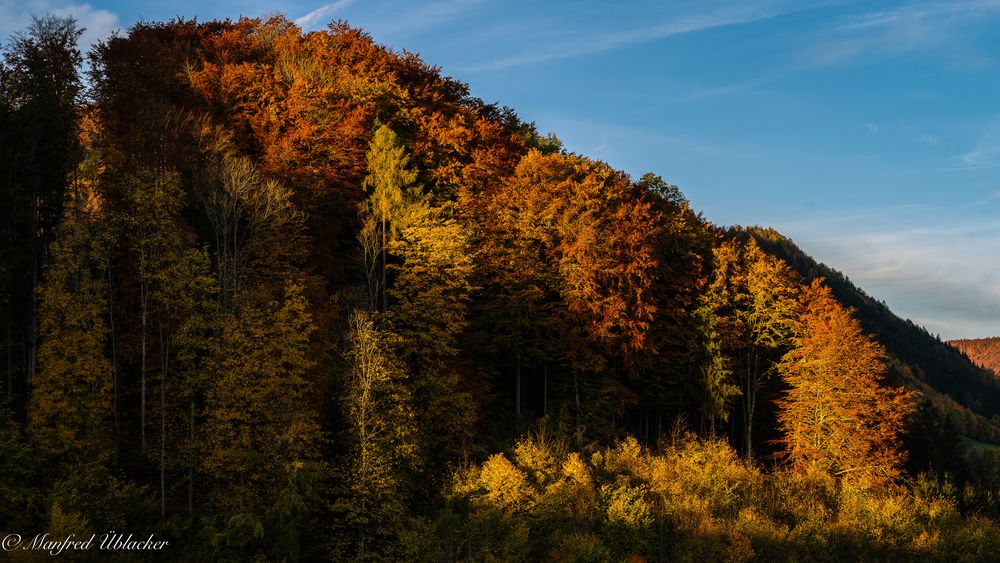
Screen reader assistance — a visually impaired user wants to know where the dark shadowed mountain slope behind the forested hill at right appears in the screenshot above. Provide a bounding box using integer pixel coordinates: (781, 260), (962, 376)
(730, 227), (1000, 470)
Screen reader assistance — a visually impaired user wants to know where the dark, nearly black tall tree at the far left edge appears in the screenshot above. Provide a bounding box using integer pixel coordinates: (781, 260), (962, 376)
(0, 16), (83, 416)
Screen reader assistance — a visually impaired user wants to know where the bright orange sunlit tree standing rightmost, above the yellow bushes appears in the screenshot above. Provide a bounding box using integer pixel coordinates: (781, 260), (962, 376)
(777, 280), (913, 484)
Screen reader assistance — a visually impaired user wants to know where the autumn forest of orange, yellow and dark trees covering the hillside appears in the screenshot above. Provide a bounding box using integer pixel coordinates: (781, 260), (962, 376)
(0, 16), (1000, 561)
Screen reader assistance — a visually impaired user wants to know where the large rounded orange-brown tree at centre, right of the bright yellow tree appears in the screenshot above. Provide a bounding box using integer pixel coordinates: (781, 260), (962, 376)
(477, 151), (660, 432)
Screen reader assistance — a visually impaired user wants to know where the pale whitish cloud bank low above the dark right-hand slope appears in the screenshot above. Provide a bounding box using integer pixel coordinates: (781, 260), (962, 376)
(784, 207), (1000, 338)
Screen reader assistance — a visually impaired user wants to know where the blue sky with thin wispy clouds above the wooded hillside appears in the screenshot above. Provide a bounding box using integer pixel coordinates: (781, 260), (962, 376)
(0, 0), (1000, 338)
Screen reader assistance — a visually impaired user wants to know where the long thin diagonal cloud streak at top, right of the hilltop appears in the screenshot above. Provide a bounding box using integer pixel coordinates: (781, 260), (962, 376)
(465, 1), (802, 72)
